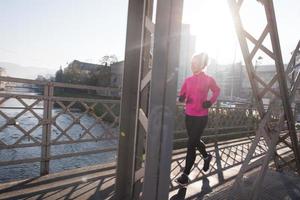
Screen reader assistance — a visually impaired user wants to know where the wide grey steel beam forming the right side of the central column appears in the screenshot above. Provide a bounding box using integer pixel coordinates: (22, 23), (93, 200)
(143, 0), (183, 200)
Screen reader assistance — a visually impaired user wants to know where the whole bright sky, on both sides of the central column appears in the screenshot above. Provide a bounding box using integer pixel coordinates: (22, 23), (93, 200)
(0, 0), (300, 69)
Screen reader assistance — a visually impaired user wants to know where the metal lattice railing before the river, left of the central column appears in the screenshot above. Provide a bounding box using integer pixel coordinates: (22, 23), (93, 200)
(0, 77), (120, 178)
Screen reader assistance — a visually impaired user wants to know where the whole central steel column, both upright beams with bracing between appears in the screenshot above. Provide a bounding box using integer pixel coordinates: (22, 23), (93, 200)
(116, 0), (183, 200)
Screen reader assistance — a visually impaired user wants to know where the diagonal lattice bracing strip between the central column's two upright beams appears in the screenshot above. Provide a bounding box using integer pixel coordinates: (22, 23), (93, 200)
(132, 0), (155, 199)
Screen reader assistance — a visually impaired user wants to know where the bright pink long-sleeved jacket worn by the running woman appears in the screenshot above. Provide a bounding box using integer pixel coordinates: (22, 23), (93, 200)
(179, 72), (220, 116)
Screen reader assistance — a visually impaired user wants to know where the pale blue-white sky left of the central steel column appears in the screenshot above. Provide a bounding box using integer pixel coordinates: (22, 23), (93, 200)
(0, 0), (128, 68)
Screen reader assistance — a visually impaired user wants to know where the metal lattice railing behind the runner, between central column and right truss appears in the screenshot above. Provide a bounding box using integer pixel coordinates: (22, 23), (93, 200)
(174, 100), (259, 147)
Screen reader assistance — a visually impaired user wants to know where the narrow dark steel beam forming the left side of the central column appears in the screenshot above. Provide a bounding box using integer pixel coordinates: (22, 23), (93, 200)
(115, 0), (145, 200)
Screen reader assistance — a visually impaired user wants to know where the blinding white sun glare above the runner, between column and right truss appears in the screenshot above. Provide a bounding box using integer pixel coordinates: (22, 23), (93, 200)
(183, 0), (237, 64)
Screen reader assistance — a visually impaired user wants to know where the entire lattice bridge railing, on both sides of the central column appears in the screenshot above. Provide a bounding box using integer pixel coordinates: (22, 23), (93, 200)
(0, 77), (257, 182)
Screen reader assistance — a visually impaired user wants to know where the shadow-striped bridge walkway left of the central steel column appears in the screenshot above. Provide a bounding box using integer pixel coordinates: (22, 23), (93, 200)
(0, 164), (115, 200)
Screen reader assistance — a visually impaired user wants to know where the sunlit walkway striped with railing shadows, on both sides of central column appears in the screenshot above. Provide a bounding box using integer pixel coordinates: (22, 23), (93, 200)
(0, 138), (300, 200)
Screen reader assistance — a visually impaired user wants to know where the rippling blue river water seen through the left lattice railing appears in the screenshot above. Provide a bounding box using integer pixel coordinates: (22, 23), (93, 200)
(0, 88), (118, 182)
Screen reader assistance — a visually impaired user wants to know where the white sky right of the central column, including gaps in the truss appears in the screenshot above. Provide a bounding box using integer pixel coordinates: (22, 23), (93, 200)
(183, 0), (300, 64)
